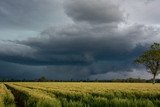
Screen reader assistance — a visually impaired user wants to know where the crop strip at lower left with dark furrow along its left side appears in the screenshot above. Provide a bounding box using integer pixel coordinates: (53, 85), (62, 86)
(6, 84), (61, 107)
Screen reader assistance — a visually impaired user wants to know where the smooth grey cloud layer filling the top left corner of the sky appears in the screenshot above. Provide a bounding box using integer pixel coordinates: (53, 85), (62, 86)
(0, 0), (67, 30)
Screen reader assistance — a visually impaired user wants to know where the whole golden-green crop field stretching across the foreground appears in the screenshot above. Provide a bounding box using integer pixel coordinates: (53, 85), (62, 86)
(0, 82), (160, 107)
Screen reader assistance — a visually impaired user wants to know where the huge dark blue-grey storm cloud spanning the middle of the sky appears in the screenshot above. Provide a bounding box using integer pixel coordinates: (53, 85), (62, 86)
(0, 25), (158, 69)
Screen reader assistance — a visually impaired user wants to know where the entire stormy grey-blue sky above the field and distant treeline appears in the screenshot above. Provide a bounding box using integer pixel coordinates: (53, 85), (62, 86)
(0, 0), (160, 80)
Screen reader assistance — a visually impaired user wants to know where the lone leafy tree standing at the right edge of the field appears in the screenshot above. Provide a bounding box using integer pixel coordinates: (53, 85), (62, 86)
(135, 43), (160, 84)
